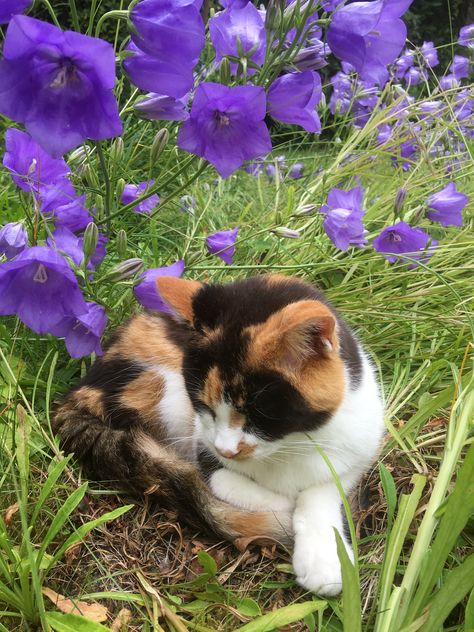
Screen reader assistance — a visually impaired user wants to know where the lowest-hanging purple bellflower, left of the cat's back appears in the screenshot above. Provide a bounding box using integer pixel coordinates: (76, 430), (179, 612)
(50, 303), (108, 358)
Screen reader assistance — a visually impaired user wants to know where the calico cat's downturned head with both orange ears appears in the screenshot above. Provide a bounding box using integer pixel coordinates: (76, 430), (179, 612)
(157, 275), (345, 460)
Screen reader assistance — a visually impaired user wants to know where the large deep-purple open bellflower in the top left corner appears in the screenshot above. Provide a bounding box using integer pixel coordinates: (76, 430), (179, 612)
(0, 15), (122, 157)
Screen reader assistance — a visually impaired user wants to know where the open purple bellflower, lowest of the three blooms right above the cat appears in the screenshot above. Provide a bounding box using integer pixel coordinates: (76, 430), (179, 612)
(373, 222), (438, 268)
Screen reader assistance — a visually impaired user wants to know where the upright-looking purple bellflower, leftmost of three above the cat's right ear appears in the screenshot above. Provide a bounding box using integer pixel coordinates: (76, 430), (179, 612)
(321, 187), (367, 251)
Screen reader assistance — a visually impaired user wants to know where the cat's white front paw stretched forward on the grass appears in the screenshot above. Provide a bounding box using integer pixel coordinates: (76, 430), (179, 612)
(293, 532), (352, 597)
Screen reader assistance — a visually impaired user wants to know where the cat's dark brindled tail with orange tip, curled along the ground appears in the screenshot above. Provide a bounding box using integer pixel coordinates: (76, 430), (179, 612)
(53, 396), (291, 544)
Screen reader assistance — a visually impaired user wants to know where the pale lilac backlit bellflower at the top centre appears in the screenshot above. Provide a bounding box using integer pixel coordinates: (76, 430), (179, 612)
(209, 2), (267, 74)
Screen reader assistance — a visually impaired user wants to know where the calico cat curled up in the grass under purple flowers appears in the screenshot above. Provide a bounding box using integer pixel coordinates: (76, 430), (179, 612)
(54, 275), (384, 595)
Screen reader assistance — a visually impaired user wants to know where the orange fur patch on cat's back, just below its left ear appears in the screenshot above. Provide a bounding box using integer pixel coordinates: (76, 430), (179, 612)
(106, 314), (183, 370)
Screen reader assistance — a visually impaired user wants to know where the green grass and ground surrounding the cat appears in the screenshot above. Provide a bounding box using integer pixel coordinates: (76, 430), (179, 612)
(0, 13), (474, 632)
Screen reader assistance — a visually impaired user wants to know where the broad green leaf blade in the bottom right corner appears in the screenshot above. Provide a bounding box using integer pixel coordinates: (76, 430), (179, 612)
(423, 553), (474, 632)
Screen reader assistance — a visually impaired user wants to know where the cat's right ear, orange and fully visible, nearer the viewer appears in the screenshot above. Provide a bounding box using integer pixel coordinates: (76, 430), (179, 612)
(252, 301), (339, 371)
